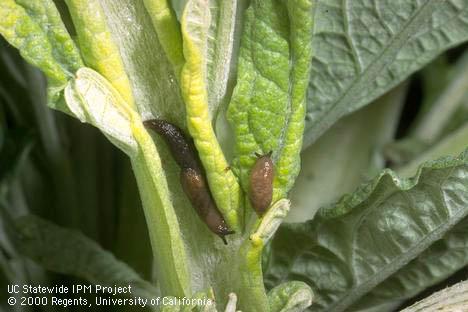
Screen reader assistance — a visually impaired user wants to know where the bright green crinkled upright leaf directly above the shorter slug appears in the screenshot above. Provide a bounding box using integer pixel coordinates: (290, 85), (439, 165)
(228, 0), (312, 199)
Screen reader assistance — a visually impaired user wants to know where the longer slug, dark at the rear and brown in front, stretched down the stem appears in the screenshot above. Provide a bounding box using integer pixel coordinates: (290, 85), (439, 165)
(144, 119), (234, 244)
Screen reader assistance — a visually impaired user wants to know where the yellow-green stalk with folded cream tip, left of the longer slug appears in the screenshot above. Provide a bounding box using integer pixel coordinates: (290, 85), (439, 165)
(65, 64), (192, 297)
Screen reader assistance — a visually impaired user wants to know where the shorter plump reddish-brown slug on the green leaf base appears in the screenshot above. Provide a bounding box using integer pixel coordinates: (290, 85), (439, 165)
(249, 152), (274, 217)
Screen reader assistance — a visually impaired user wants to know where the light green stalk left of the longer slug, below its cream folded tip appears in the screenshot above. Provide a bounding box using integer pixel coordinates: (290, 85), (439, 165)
(131, 126), (191, 297)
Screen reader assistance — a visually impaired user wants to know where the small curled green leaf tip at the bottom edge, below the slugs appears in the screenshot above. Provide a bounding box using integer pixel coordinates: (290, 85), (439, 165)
(268, 282), (314, 312)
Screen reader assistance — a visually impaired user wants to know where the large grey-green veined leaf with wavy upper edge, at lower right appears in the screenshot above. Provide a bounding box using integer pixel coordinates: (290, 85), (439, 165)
(267, 152), (468, 311)
